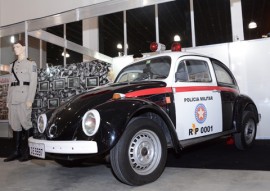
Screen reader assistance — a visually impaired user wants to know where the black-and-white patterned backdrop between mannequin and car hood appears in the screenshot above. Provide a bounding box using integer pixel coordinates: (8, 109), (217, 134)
(32, 60), (111, 127)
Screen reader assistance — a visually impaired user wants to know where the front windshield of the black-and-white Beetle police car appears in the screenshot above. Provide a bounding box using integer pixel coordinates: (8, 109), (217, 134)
(116, 56), (171, 82)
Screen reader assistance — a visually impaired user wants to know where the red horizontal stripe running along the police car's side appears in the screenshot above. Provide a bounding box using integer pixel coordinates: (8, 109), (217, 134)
(125, 86), (239, 97)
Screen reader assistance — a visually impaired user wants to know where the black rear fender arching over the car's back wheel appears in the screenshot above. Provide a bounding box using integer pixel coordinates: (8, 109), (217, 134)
(234, 95), (259, 132)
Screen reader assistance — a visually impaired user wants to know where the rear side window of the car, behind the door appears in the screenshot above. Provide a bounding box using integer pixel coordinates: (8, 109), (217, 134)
(212, 60), (235, 85)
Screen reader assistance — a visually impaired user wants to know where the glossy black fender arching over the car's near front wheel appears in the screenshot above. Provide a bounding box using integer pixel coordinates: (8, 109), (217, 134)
(89, 99), (180, 154)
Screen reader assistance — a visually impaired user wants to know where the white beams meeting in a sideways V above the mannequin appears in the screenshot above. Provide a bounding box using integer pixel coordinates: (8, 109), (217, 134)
(0, 0), (173, 63)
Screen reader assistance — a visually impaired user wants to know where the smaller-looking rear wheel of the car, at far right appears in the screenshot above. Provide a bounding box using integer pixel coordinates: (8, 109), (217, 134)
(234, 111), (257, 150)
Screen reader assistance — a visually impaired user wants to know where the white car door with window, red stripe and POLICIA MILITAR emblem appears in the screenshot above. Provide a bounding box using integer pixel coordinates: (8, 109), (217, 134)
(172, 56), (222, 140)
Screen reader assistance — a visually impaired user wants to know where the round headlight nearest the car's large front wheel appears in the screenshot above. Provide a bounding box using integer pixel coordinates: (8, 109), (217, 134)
(82, 109), (100, 136)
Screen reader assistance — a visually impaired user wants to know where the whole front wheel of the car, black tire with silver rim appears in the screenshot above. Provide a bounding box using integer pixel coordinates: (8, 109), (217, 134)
(110, 118), (167, 186)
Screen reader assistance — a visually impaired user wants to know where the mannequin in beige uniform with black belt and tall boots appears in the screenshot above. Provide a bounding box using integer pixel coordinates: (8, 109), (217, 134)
(4, 41), (37, 162)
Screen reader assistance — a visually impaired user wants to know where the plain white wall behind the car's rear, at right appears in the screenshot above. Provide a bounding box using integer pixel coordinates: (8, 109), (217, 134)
(184, 38), (270, 139)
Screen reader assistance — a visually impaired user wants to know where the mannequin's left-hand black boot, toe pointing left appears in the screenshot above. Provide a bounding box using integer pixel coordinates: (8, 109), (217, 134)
(4, 131), (22, 162)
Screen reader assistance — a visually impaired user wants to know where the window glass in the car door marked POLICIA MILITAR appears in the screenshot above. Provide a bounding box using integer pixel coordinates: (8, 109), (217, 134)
(175, 60), (212, 82)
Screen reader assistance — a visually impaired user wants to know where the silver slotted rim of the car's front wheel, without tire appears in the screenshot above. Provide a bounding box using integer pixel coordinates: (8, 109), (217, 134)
(128, 130), (162, 175)
